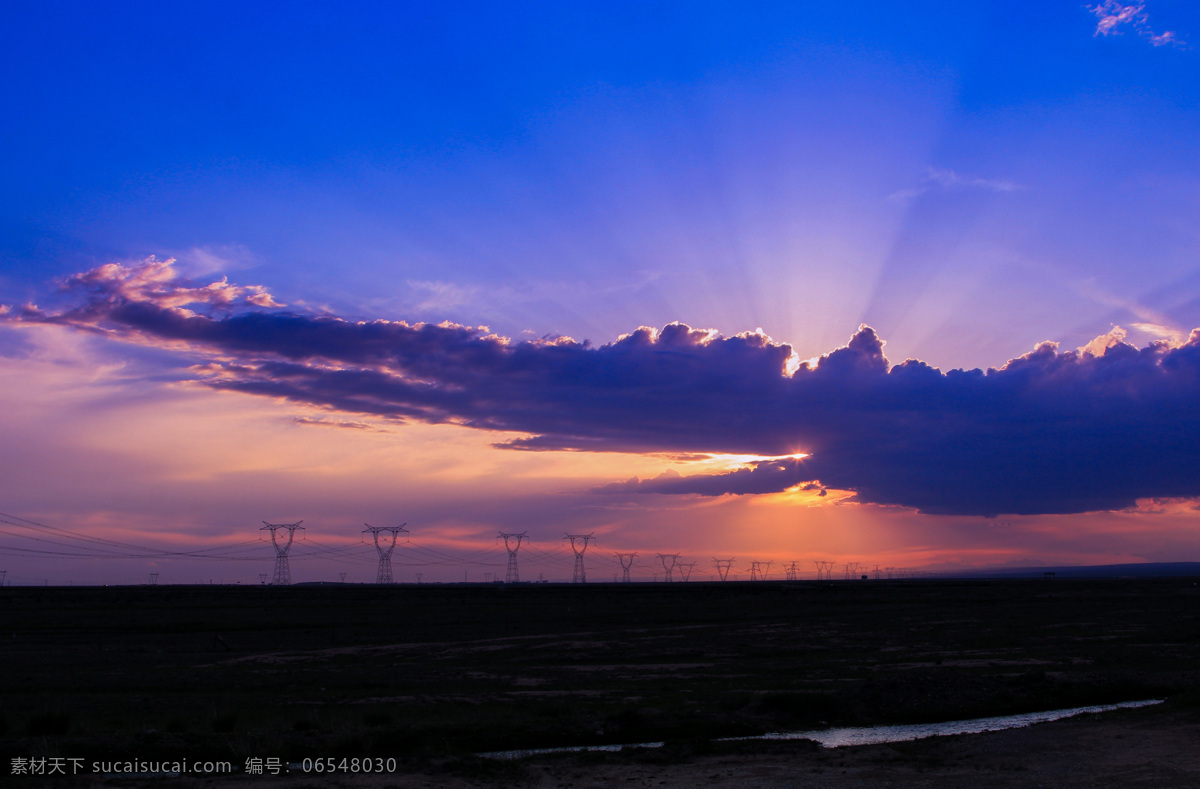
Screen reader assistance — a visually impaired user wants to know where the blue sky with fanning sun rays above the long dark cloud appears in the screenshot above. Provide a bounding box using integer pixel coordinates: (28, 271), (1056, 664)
(0, 1), (1200, 577)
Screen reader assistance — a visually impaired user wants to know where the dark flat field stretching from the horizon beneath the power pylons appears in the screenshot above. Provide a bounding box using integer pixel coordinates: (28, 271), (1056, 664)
(0, 578), (1200, 785)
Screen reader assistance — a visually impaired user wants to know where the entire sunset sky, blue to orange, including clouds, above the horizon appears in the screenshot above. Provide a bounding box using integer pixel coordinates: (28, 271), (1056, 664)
(0, 0), (1200, 584)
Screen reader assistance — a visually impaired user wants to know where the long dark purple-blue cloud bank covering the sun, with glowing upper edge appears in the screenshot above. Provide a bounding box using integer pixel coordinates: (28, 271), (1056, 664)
(6, 263), (1200, 514)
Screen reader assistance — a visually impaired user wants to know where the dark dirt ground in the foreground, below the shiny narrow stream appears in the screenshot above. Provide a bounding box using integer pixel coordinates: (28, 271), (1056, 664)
(91, 709), (1200, 789)
